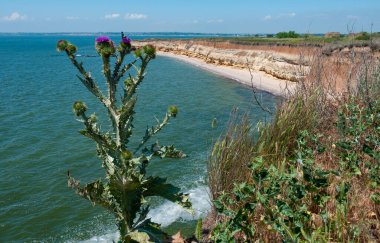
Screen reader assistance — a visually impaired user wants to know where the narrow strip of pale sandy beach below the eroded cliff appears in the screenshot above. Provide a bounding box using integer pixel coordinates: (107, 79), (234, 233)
(157, 51), (297, 97)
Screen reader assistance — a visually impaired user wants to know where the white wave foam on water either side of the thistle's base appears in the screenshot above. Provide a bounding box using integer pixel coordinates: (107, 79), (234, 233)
(81, 186), (211, 243)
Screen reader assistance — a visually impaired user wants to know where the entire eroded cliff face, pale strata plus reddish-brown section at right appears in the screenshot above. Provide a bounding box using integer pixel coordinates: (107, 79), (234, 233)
(134, 39), (380, 92)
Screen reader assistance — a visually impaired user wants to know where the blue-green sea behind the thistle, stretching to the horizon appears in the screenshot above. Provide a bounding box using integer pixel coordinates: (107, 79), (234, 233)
(0, 33), (278, 242)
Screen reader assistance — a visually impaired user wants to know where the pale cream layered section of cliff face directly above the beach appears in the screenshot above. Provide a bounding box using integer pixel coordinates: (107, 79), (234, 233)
(137, 40), (310, 82)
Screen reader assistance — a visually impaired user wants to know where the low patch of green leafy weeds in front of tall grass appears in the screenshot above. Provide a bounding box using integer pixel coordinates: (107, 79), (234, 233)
(213, 132), (330, 242)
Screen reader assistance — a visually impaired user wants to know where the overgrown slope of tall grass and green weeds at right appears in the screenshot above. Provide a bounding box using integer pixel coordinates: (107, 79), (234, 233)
(209, 47), (380, 242)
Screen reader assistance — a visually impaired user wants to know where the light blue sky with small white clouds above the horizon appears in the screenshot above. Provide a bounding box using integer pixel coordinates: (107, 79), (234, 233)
(0, 0), (380, 34)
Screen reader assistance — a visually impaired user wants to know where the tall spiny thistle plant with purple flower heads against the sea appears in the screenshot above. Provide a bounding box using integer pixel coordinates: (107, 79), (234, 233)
(57, 33), (191, 242)
